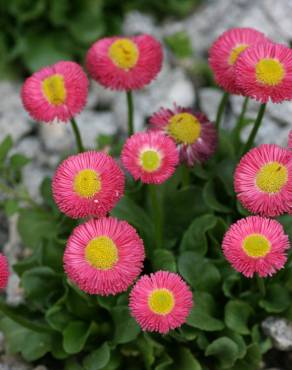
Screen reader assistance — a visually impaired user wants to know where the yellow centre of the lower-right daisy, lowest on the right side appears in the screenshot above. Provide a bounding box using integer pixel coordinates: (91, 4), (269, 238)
(242, 234), (271, 258)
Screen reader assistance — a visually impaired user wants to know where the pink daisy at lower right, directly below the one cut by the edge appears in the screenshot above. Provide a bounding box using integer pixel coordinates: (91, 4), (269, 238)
(222, 216), (290, 277)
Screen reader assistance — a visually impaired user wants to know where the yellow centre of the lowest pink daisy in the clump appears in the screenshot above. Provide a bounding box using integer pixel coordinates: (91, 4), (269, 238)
(148, 289), (175, 315)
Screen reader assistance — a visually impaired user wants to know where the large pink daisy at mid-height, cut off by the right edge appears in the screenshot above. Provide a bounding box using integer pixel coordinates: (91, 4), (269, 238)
(234, 144), (292, 217)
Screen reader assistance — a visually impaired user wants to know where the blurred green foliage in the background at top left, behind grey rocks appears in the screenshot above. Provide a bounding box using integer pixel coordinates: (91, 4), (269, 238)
(0, 0), (200, 78)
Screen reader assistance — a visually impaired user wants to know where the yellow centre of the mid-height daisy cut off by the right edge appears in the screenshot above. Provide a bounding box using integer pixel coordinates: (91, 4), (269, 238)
(256, 161), (288, 194)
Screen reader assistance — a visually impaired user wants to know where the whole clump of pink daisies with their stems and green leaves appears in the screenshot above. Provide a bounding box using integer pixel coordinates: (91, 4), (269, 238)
(0, 24), (292, 369)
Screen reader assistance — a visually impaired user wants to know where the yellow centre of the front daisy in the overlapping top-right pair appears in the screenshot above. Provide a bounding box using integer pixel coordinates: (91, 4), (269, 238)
(256, 58), (285, 86)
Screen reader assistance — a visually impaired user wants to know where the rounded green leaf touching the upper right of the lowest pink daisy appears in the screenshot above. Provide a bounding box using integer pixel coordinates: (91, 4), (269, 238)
(178, 252), (221, 291)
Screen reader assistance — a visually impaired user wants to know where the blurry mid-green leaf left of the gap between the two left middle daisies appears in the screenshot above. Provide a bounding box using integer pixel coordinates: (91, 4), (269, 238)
(17, 209), (58, 248)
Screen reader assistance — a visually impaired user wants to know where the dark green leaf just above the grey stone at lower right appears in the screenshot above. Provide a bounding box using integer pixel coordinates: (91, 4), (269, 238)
(259, 284), (291, 313)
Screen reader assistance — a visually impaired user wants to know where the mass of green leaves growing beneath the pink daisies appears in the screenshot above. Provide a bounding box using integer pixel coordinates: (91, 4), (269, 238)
(0, 79), (292, 370)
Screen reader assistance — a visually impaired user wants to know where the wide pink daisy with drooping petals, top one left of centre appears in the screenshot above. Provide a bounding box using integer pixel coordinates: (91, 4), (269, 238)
(86, 35), (163, 91)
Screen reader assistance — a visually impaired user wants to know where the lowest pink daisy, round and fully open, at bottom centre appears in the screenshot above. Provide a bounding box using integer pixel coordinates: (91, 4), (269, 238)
(129, 271), (193, 334)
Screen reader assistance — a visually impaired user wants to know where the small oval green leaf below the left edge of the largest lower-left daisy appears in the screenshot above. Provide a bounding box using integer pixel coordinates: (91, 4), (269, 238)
(63, 321), (90, 354)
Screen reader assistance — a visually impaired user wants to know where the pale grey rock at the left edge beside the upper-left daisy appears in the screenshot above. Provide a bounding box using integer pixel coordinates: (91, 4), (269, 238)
(0, 81), (33, 142)
